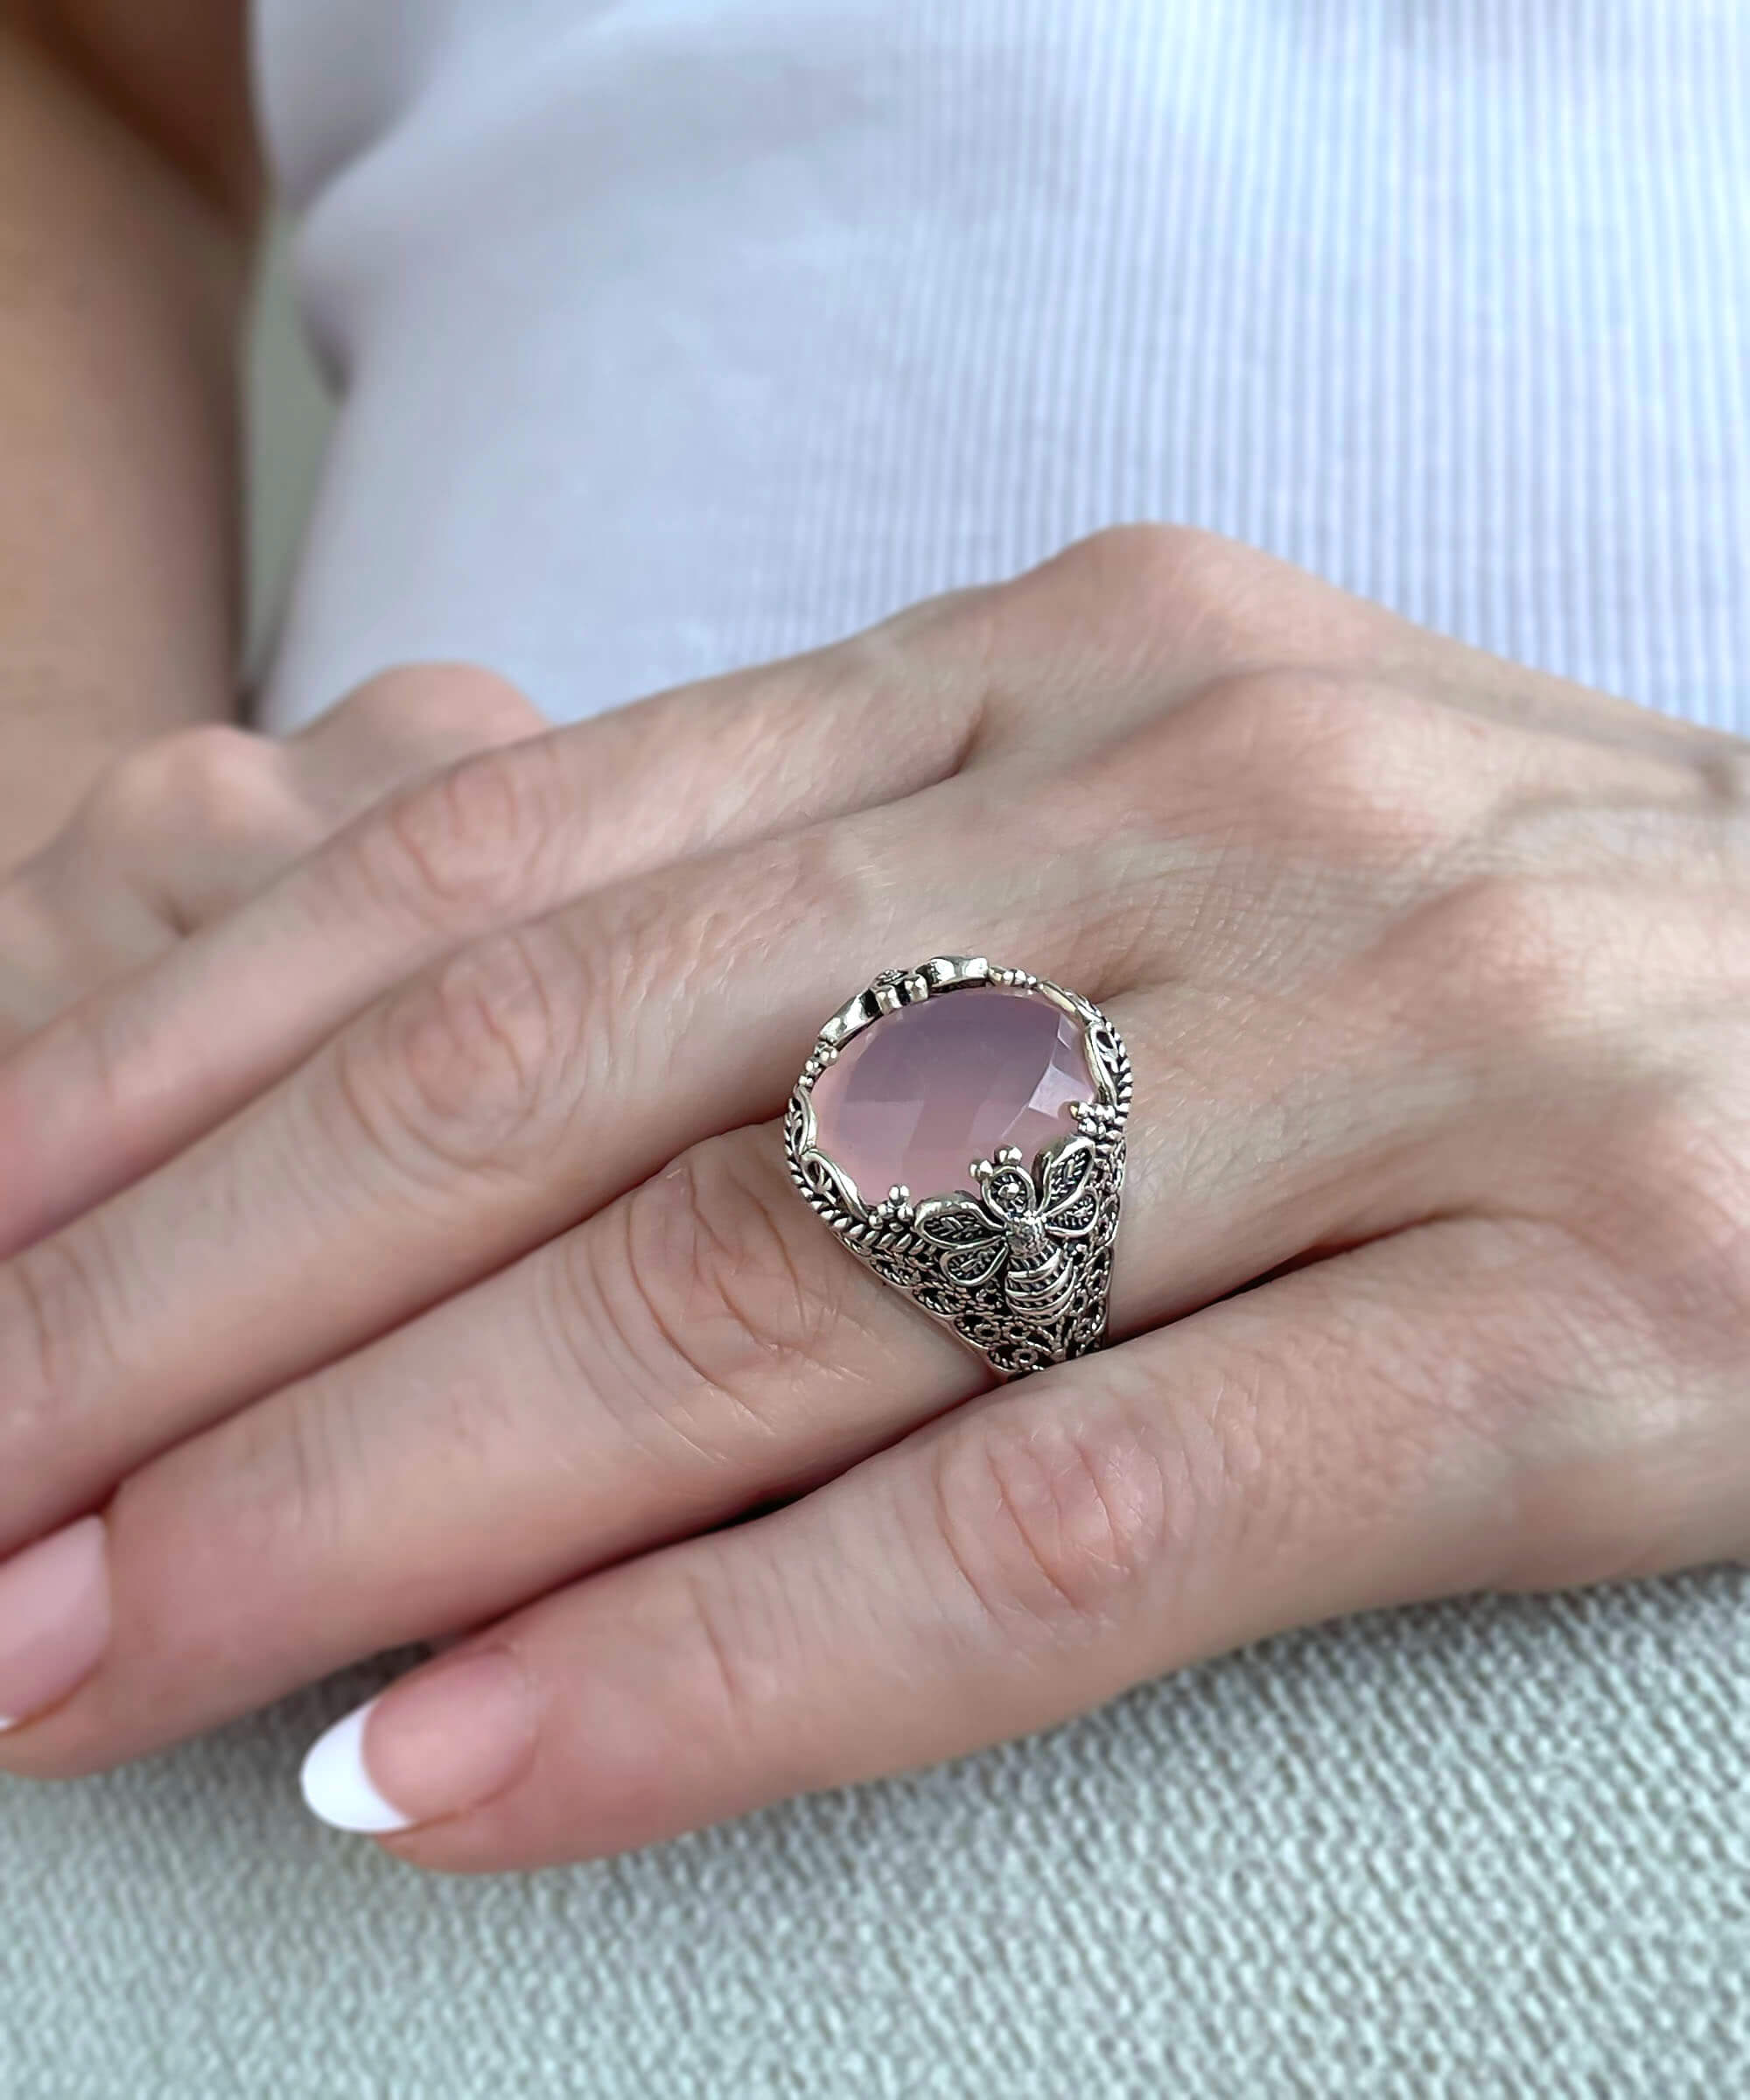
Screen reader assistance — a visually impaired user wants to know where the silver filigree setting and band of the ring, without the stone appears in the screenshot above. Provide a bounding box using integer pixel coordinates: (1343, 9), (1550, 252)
(784, 956), (1130, 1377)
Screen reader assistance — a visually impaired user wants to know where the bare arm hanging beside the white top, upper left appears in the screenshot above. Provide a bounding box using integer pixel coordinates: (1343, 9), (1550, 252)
(0, 0), (258, 867)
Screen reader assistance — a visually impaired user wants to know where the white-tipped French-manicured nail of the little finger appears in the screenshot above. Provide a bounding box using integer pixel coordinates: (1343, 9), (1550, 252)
(303, 1648), (538, 1836)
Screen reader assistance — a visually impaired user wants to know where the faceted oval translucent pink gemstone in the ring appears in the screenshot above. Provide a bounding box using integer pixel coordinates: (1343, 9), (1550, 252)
(816, 985), (1095, 1203)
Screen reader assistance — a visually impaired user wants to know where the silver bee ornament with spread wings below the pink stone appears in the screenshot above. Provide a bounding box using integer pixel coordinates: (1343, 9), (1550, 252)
(916, 1136), (1099, 1325)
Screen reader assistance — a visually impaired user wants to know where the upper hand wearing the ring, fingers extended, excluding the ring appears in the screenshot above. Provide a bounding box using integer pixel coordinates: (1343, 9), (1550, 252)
(0, 529), (1750, 1869)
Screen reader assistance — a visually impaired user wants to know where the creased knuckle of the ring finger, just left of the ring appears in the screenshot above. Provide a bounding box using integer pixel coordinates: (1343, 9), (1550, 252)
(559, 1130), (847, 1468)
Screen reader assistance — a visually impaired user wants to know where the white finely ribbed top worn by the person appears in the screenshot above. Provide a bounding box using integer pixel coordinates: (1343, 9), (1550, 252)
(261, 0), (1750, 724)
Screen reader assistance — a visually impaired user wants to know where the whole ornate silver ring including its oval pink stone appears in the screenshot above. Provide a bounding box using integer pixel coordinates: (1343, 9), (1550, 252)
(784, 956), (1130, 1377)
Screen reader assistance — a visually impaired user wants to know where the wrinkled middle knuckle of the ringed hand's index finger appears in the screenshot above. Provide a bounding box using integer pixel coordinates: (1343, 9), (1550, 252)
(349, 739), (563, 934)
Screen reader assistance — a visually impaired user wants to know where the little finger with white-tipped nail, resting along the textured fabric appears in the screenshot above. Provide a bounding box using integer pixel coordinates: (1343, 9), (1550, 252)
(279, 1220), (1723, 1871)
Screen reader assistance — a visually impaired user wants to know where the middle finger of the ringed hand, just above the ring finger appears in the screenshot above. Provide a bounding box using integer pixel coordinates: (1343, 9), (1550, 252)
(0, 779), (1114, 1550)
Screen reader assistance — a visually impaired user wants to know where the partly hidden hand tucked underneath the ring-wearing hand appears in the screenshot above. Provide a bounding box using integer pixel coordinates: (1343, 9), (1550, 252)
(0, 666), (546, 1050)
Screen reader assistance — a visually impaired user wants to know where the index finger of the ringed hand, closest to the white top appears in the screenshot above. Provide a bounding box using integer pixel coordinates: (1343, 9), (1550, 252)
(0, 617), (976, 1251)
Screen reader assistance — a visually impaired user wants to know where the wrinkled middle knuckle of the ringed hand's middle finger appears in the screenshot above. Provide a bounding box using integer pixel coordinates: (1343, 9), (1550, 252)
(334, 926), (584, 1170)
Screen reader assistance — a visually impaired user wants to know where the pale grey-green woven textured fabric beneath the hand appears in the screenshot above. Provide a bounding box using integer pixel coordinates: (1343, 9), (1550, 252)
(0, 1573), (1750, 2100)
